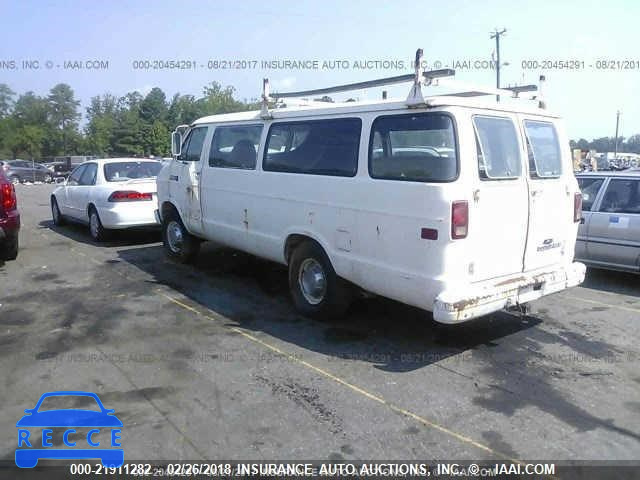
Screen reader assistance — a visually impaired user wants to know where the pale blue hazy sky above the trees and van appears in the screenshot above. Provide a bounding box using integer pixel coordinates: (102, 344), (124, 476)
(0, 0), (640, 140)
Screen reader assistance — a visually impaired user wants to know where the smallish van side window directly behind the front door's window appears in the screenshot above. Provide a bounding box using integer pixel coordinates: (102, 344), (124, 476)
(209, 125), (262, 170)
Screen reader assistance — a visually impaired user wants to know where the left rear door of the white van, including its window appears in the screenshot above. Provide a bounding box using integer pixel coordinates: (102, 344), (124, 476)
(467, 113), (529, 281)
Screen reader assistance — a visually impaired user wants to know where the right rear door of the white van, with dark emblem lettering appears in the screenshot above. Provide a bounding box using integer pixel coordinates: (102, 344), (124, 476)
(522, 117), (576, 271)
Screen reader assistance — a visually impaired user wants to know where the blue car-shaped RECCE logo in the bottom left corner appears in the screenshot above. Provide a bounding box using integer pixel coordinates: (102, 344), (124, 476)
(16, 391), (124, 468)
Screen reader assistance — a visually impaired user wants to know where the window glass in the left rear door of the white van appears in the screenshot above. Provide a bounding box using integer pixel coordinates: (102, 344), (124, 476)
(473, 116), (522, 180)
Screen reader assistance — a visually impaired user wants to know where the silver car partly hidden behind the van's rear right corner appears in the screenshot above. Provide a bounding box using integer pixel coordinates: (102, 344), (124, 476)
(576, 170), (640, 273)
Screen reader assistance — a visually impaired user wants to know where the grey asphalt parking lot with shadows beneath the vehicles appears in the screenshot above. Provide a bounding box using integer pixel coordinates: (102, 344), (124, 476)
(0, 185), (640, 460)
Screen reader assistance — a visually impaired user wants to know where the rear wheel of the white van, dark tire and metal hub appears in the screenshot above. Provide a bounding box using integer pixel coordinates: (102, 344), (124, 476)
(289, 241), (353, 320)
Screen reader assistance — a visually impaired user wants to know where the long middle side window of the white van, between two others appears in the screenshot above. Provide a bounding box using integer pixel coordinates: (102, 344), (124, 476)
(262, 118), (362, 177)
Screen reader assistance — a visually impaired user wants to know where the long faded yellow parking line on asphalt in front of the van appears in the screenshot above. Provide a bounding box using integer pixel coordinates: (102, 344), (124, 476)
(157, 291), (525, 465)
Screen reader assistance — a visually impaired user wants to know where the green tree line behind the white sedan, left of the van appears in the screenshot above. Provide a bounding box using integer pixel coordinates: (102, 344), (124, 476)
(0, 82), (259, 160)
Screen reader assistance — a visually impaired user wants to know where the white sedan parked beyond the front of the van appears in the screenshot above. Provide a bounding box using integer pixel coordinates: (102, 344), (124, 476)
(51, 158), (163, 241)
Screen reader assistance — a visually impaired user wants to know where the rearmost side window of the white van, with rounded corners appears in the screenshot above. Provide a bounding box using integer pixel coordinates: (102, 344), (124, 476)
(369, 113), (458, 182)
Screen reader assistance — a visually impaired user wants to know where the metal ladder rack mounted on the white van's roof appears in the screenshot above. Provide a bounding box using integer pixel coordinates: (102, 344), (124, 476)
(261, 48), (544, 118)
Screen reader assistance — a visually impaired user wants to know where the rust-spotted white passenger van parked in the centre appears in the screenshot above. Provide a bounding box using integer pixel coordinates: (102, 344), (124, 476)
(157, 62), (585, 323)
